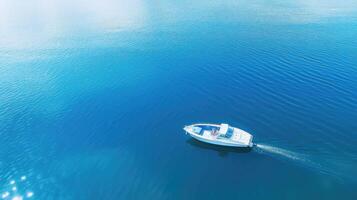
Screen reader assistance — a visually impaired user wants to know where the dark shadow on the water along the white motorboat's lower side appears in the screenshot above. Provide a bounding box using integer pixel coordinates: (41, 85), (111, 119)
(186, 138), (252, 157)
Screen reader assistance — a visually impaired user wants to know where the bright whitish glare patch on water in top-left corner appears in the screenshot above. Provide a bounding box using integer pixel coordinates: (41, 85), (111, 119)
(0, 0), (146, 49)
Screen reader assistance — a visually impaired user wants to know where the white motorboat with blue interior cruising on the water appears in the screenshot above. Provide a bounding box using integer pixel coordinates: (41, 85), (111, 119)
(183, 124), (253, 147)
